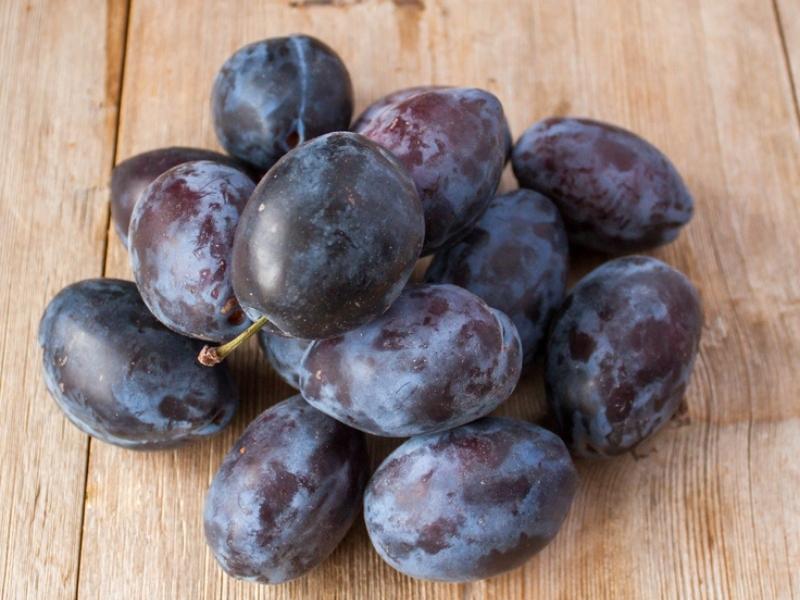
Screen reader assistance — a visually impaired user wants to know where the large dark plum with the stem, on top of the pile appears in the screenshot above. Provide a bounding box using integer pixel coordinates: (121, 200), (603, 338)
(233, 132), (425, 339)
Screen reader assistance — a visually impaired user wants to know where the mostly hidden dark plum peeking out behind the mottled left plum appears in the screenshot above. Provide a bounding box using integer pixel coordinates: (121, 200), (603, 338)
(111, 146), (252, 247)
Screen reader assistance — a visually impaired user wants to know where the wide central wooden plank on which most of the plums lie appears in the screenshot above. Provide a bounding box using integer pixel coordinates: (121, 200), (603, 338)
(79, 0), (800, 600)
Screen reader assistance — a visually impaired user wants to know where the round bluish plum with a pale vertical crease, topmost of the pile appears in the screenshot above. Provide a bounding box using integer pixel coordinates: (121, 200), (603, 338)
(211, 35), (353, 170)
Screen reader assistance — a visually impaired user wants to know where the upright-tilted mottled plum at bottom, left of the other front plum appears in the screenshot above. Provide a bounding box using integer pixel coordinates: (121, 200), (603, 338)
(204, 396), (369, 583)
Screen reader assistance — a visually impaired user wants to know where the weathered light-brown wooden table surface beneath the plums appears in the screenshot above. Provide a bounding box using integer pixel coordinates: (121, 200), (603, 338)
(0, 0), (800, 600)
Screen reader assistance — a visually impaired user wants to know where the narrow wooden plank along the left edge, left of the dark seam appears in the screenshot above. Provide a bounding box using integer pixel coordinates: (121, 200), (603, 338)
(0, 0), (126, 598)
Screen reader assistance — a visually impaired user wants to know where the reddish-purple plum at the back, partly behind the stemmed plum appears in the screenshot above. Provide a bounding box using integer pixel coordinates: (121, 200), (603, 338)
(354, 87), (510, 254)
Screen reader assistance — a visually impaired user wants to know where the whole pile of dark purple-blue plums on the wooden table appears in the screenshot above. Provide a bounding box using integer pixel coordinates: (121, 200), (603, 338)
(39, 35), (702, 583)
